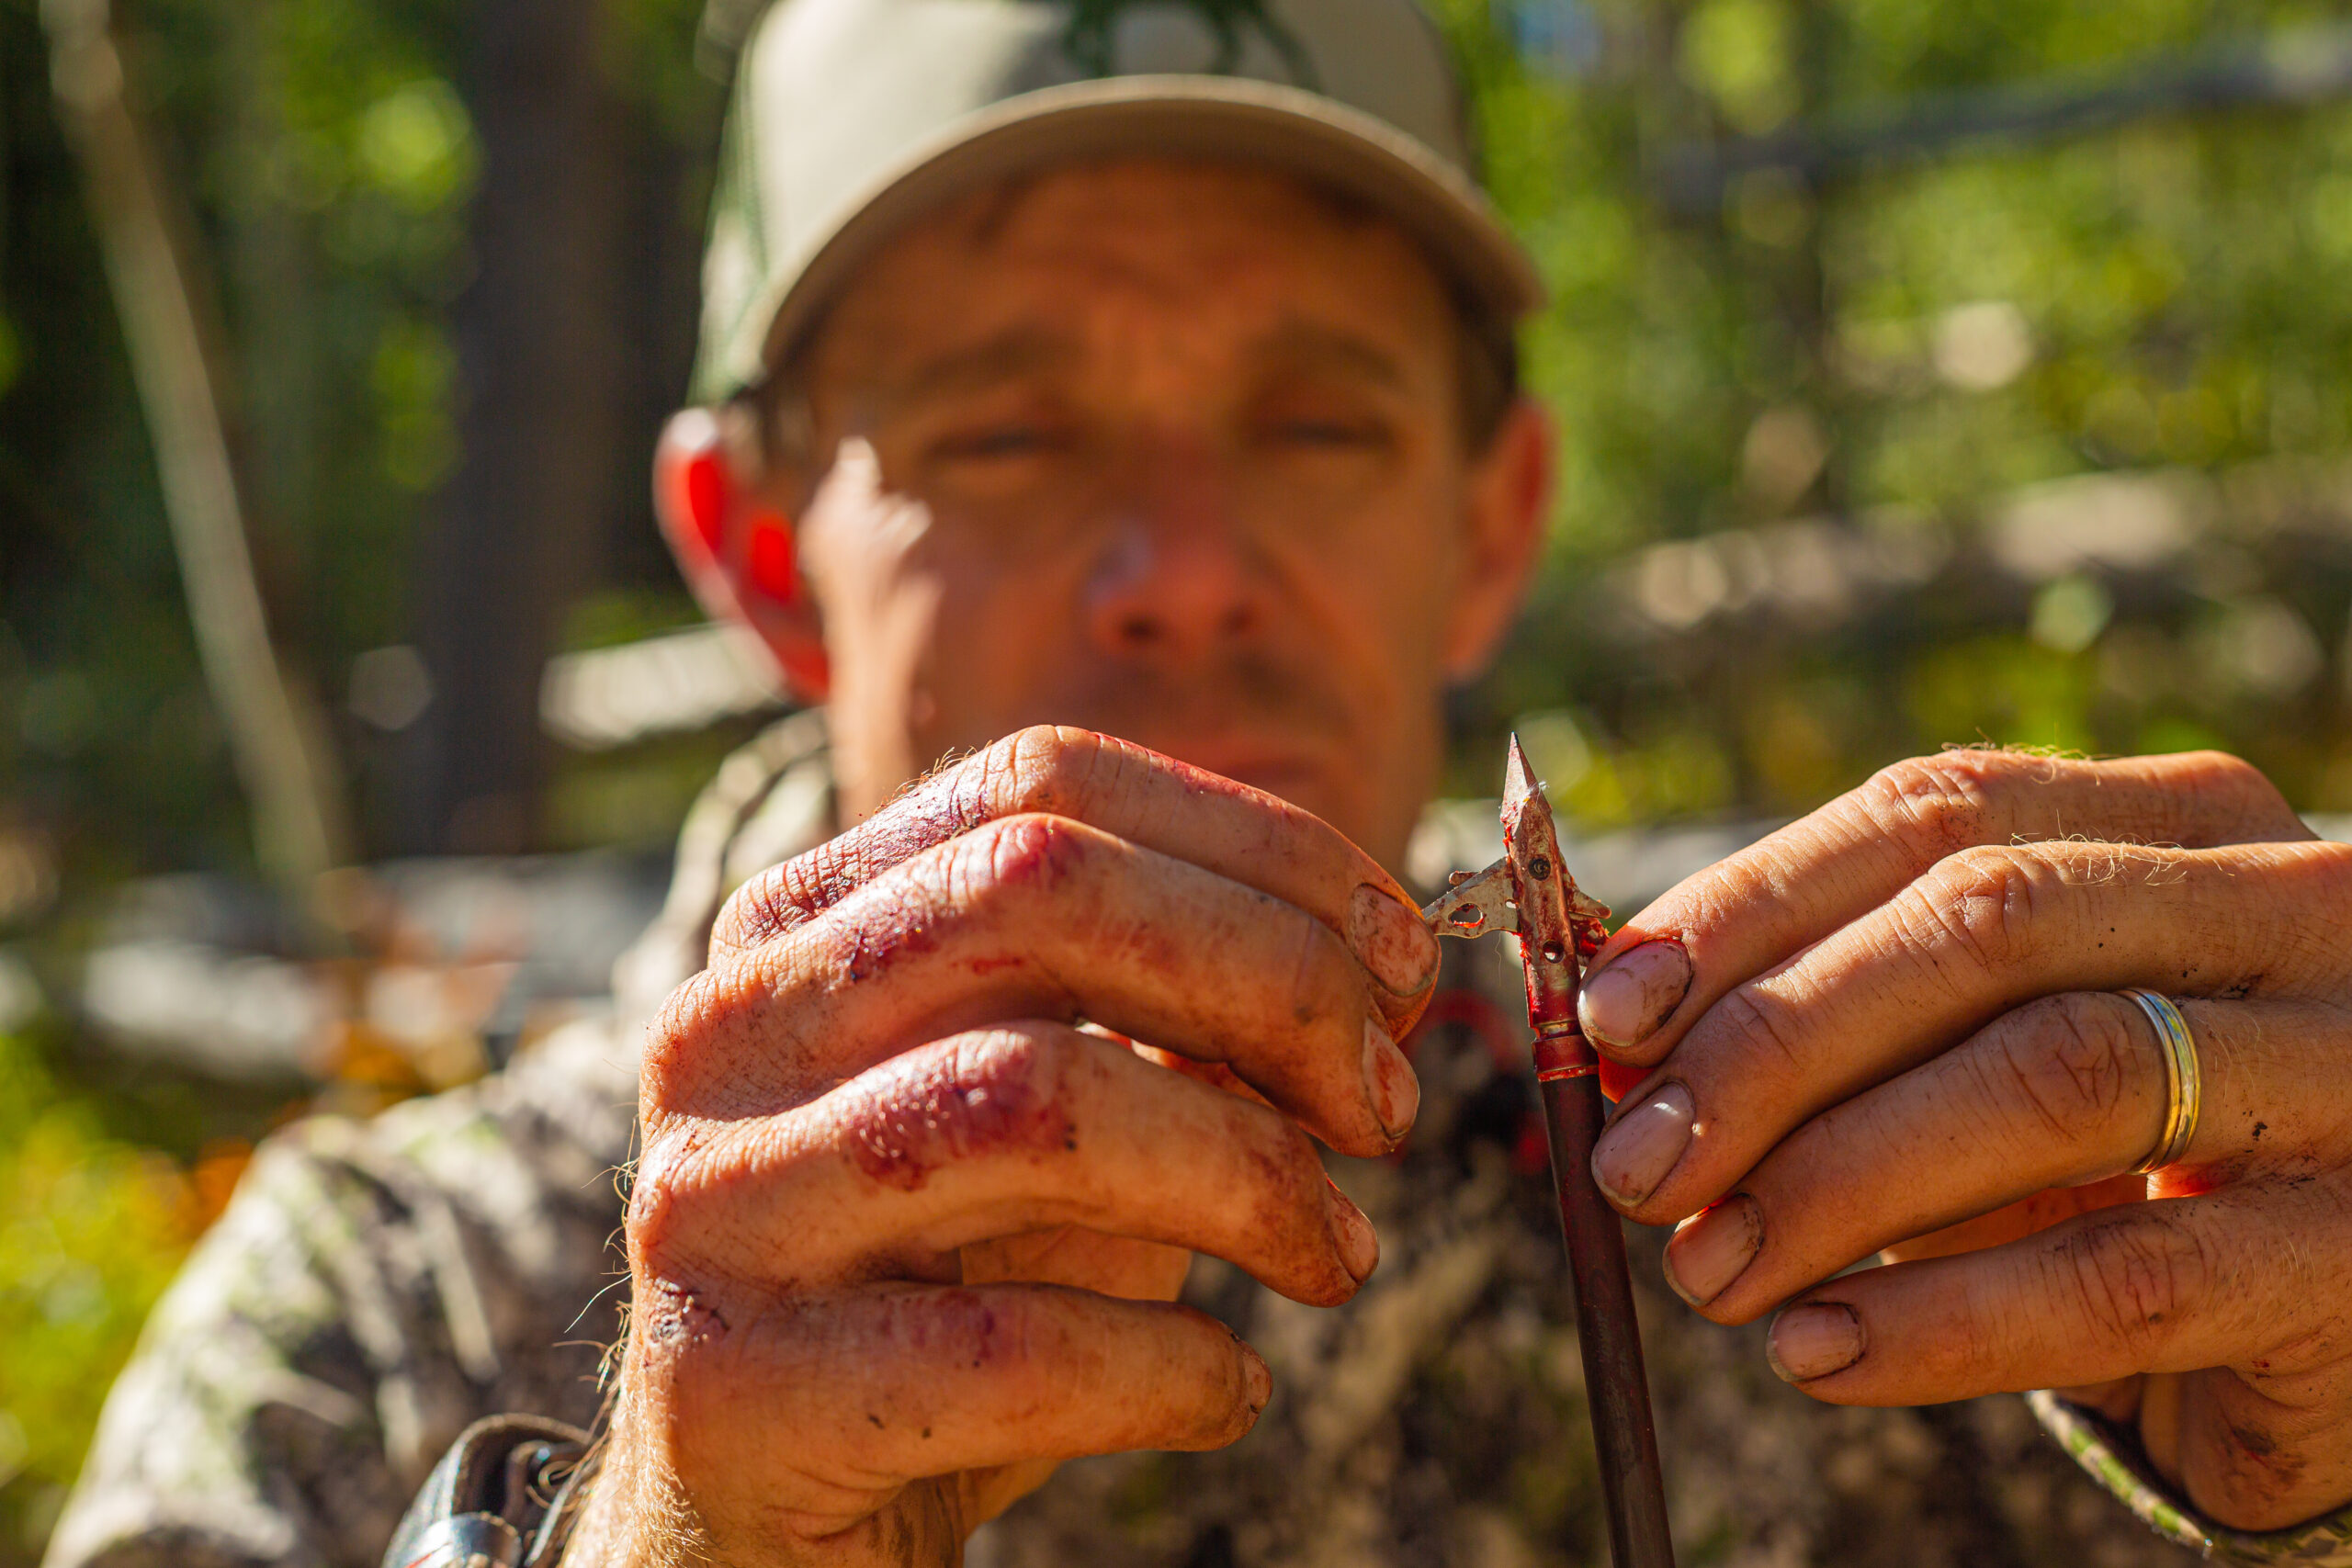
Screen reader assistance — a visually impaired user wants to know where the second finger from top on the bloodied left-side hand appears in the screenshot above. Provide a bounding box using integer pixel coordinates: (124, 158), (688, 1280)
(642, 816), (1419, 1155)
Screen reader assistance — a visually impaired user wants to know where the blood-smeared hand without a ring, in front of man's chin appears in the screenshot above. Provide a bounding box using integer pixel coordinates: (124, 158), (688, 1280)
(570, 728), (1437, 1565)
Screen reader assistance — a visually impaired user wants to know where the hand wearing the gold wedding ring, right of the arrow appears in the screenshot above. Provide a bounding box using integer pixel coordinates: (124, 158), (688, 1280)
(1583, 750), (2352, 1530)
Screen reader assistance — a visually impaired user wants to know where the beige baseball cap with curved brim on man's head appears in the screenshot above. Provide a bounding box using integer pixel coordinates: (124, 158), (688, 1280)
(694, 0), (1541, 402)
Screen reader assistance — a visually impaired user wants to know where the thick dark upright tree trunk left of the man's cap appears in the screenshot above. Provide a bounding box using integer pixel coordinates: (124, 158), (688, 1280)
(400, 0), (628, 853)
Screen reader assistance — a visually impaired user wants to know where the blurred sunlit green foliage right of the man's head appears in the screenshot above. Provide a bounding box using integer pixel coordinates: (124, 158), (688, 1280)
(1440, 0), (2352, 828)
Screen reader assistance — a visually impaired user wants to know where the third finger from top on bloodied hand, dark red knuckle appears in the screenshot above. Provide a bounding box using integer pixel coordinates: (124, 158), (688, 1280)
(630, 1022), (1378, 1304)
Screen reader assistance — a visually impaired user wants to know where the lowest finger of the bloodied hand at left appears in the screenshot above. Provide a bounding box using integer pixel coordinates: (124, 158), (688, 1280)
(633, 1283), (1272, 1559)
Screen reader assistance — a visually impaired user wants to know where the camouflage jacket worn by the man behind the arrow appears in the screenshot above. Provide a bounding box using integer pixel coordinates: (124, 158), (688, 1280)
(47, 719), (2352, 1568)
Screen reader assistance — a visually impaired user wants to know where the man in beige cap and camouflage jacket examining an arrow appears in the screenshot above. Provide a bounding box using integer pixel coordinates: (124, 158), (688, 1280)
(51, 0), (2352, 1565)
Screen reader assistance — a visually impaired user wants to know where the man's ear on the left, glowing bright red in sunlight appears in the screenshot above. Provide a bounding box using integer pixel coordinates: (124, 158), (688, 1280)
(654, 409), (831, 703)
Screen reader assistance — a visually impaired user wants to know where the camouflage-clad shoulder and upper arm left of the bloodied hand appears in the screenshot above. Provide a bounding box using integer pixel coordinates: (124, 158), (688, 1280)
(50, 1021), (635, 1563)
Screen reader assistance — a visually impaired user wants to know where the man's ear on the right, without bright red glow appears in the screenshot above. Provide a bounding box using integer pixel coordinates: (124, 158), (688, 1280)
(1446, 398), (1557, 682)
